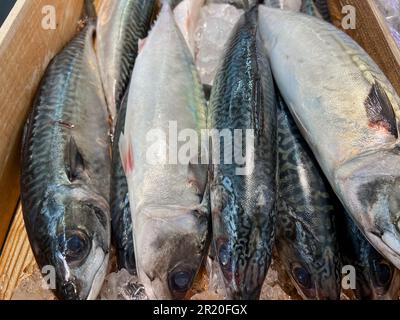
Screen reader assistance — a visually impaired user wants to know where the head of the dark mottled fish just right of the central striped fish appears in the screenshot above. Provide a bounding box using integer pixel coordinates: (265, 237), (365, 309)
(276, 218), (341, 300)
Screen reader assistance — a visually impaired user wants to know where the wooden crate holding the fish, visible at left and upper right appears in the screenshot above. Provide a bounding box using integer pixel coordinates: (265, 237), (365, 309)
(0, 0), (400, 300)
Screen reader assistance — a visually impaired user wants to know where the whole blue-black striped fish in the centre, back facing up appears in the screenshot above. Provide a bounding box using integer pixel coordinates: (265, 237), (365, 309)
(208, 8), (276, 299)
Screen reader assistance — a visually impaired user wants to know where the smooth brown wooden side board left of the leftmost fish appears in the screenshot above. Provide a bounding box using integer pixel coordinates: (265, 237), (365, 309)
(0, 0), (83, 248)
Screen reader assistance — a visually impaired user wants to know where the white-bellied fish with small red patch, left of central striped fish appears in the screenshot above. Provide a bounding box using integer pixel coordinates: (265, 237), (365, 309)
(119, 4), (210, 299)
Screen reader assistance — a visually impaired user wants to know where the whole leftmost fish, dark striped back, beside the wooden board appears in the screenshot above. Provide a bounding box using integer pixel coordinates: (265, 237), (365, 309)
(21, 23), (111, 299)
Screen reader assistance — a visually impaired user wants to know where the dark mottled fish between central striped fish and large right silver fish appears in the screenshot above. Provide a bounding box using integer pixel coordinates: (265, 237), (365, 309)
(276, 97), (341, 299)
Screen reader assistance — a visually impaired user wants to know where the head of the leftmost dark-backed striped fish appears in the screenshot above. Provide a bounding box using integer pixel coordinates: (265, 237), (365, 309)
(48, 188), (111, 300)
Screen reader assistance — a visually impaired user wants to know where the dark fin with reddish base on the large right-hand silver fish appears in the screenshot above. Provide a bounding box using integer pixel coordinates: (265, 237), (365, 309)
(364, 81), (398, 138)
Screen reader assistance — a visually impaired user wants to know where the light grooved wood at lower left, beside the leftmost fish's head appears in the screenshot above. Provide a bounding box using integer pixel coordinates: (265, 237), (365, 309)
(0, 206), (37, 300)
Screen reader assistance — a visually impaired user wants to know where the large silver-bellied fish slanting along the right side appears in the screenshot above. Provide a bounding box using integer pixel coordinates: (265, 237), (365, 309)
(259, 6), (400, 267)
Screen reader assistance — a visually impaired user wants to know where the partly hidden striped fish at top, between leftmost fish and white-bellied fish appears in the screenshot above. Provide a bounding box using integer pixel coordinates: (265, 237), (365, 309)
(97, 0), (158, 118)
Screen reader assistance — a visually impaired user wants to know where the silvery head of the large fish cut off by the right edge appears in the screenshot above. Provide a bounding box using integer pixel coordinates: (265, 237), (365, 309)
(336, 147), (400, 268)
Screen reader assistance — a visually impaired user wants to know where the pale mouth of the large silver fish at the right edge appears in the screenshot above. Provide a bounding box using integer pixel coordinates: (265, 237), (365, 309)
(366, 231), (400, 269)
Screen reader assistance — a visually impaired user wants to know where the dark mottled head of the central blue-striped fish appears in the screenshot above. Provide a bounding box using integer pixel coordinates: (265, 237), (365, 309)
(211, 181), (274, 300)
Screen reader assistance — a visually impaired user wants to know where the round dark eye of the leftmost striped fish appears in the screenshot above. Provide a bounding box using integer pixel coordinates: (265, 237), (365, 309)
(58, 231), (91, 264)
